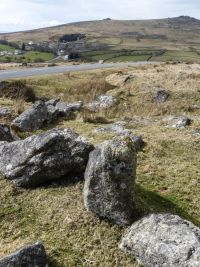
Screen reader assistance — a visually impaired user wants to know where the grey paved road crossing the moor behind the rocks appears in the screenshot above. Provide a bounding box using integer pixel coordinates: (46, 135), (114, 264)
(0, 62), (156, 80)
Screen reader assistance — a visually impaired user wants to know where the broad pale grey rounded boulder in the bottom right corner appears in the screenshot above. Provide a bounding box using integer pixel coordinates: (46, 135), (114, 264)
(119, 214), (200, 267)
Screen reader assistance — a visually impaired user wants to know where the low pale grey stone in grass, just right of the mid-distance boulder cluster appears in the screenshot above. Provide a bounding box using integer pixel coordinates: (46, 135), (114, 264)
(84, 95), (117, 112)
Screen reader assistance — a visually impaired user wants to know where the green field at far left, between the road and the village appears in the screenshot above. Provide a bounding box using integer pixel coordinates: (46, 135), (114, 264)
(0, 52), (54, 63)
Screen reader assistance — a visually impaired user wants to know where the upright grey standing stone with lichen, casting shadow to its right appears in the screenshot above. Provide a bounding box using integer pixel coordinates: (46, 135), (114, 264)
(84, 136), (136, 225)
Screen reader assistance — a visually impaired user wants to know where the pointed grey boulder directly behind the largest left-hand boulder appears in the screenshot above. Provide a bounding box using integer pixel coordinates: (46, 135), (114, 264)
(11, 101), (47, 132)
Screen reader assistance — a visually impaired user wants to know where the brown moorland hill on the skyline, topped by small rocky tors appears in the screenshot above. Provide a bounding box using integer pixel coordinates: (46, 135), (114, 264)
(0, 16), (200, 49)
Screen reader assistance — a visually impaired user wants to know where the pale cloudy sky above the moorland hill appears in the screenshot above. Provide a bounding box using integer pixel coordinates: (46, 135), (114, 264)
(0, 0), (200, 32)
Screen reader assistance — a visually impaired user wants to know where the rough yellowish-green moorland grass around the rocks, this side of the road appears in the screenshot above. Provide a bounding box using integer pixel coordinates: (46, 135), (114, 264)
(0, 64), (200, 267)
